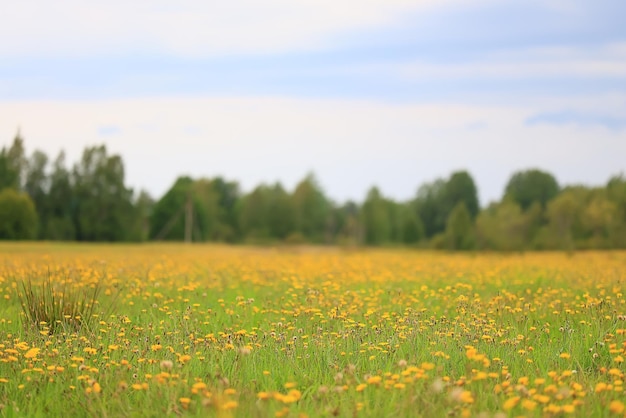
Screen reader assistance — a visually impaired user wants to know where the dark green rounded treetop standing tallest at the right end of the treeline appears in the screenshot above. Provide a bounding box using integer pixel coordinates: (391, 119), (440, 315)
(504, 169), (559, 211)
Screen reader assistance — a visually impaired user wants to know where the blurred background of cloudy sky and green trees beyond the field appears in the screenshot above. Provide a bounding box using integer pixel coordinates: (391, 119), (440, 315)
(0, 0), (626, 250)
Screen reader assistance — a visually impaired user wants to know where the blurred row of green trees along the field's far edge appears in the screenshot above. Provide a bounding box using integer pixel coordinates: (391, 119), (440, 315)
(0, 134), (626, 251)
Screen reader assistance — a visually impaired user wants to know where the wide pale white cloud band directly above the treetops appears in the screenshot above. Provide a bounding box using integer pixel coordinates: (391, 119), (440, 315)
(0, 96), (626, 202)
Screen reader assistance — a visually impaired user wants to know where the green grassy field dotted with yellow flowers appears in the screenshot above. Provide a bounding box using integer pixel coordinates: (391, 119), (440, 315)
(0, 244), (626, 417)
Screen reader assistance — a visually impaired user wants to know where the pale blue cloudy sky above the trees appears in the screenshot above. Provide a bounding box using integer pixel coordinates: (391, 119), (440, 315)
(0, 0), (626, 204)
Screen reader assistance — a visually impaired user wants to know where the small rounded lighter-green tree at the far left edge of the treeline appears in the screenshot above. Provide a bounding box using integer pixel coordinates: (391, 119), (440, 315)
(0, 188), (37, 240)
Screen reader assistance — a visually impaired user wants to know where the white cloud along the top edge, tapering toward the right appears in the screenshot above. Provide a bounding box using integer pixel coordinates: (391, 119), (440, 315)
(0, 0), (484, 56)
